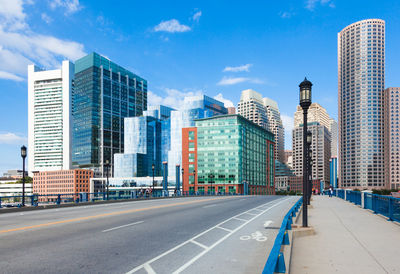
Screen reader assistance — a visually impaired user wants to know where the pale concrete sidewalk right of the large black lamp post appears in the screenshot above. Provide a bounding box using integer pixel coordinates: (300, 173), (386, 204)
(290, 196), (400, 274)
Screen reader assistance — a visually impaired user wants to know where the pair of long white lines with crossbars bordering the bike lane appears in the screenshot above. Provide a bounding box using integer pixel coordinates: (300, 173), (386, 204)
(126, 198), (290, 274)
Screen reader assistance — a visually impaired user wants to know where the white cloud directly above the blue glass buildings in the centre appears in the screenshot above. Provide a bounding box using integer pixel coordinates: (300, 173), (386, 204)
(147, 88), (204, 109)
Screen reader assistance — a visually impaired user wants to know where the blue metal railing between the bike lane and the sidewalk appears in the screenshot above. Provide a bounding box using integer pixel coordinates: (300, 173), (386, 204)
(262, 198), (303, 274)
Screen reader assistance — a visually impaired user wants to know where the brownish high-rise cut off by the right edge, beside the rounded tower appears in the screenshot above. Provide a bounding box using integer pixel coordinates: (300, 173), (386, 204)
(384, 88), (400, 189)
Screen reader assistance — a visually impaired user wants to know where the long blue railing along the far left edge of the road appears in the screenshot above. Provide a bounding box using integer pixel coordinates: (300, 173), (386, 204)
(0, 190), (243, 208)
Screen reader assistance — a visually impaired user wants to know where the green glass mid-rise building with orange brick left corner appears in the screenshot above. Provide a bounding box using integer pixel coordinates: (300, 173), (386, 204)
(182, 115), (275, 194)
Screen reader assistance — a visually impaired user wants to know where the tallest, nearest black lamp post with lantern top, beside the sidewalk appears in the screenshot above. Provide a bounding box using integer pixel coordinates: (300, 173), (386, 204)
(299, 78), (312, 227)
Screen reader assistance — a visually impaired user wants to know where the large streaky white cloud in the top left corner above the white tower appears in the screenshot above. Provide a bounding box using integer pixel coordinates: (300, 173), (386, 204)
(0, 0), (85, 81)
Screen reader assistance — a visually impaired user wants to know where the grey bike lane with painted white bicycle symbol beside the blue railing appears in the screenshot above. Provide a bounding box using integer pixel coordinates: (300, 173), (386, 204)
(177, 197), (299, 273)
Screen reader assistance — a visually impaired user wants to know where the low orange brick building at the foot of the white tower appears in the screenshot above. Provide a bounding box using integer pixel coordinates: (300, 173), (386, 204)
(33, 169), (93, 199)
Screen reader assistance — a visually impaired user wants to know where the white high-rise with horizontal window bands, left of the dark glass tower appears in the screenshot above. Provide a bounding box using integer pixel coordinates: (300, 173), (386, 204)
(28, 61), (74, 173)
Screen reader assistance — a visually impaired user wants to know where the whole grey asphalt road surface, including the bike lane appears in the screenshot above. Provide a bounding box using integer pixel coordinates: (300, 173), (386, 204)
(0, 196), (298, 273)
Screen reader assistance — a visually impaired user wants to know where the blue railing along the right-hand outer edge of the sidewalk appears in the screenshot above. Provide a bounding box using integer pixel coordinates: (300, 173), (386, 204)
(324, 189), (400, 222)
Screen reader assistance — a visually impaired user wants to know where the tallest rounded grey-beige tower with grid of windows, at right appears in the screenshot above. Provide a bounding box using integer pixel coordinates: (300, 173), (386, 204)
(338, 19), (385, 189)
